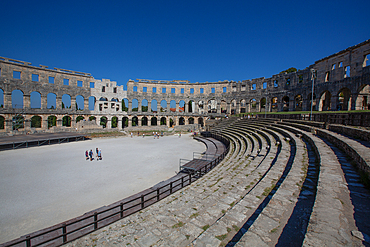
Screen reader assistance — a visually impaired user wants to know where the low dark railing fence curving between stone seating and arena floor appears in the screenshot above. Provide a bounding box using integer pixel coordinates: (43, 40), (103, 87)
(0, 134), (229, 247)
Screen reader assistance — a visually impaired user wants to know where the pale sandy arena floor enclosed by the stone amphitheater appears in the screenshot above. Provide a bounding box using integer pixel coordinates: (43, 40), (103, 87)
(0, 135), (206, 243)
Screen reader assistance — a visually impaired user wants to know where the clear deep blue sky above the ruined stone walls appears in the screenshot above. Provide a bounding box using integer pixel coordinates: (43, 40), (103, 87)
(0, 0), (370, 89)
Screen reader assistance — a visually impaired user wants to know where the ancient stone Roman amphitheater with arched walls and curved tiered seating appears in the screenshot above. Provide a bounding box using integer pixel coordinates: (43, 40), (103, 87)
(0, 40), (370, 246)
